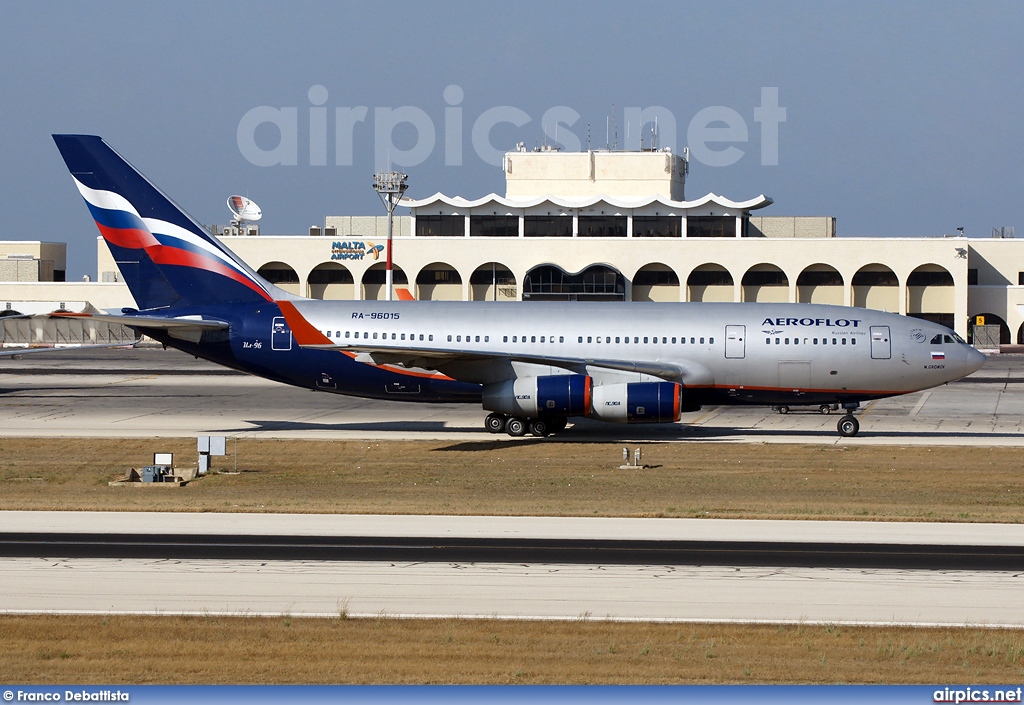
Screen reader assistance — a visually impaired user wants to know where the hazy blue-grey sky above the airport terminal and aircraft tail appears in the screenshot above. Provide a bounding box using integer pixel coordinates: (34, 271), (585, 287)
(0, 0), (1024, 279)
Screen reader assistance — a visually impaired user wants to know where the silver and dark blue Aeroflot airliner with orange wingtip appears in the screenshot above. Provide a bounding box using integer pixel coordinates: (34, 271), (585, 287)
(54, 134), (985, 437)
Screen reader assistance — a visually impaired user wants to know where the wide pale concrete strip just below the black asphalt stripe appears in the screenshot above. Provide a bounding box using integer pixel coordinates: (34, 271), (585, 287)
(0, 558), (1024, 628)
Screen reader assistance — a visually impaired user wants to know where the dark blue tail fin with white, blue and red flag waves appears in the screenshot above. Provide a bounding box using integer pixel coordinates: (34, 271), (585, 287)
(53, 134), (274, 309)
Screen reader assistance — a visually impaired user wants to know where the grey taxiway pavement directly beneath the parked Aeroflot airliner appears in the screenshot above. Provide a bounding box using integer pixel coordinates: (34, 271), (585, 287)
(0, 347), (1024, 447)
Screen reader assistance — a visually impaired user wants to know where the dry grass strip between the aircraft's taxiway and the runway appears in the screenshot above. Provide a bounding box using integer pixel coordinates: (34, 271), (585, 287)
(0, 438), (1024, 523)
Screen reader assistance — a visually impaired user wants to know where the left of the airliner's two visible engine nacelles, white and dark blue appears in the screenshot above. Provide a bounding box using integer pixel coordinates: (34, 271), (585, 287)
(483, 374), (593, 418)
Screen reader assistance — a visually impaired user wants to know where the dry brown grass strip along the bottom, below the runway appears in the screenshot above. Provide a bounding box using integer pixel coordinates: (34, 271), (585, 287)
(0, 616), (1024, 683)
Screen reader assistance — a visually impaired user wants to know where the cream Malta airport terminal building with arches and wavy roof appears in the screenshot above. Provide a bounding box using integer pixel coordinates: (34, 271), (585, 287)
(0, 149), (1024, 347)
